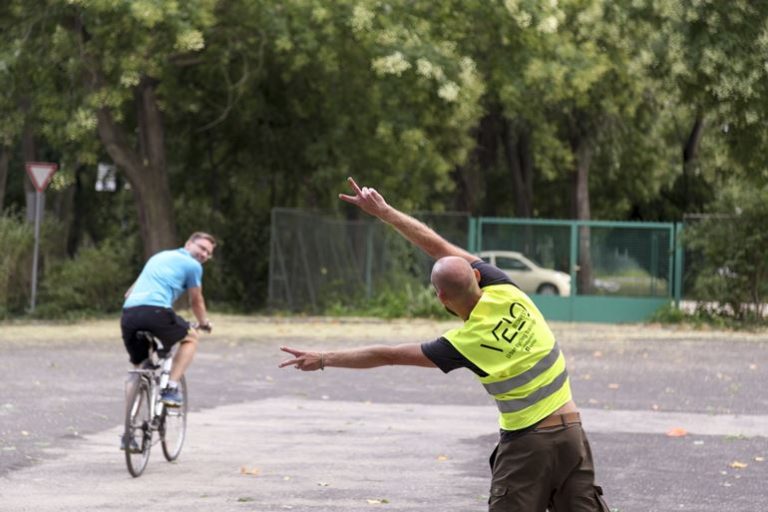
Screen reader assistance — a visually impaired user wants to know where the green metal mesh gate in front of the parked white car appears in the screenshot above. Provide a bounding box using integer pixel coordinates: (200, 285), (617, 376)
(468, 217), (682, 322)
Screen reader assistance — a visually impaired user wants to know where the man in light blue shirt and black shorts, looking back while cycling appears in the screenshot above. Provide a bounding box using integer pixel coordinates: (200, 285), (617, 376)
(120, 232), (216, 407)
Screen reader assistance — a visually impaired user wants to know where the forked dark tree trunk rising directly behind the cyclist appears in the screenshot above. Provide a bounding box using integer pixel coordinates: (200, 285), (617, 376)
(97, 79), (177, 258)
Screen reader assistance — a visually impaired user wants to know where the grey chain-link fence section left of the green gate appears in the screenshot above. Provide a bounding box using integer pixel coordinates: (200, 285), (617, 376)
(269, 208), (469, 312)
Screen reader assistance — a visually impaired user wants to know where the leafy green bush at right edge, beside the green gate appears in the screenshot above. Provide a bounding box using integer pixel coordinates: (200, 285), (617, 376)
(685, 182), (768, 322)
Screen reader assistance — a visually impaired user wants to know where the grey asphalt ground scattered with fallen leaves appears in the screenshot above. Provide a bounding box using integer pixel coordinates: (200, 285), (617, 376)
(0, 317), (768, 512)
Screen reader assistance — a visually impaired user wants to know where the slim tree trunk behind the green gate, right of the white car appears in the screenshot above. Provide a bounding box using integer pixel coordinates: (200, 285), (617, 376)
(571, 136), (593, 295)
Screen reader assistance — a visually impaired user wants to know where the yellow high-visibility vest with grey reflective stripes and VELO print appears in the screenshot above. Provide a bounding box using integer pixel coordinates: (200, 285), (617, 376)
(443, 284), (571, 430)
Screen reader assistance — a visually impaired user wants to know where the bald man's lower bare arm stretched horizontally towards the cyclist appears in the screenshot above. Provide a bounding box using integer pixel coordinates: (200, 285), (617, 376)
(280, 343), (435, 371)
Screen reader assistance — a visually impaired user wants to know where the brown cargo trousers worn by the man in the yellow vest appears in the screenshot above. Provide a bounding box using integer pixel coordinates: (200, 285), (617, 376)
(488, 423), (610, 512)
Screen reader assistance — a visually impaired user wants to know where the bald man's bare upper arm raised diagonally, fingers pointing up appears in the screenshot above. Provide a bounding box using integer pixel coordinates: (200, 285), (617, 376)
(339, 178), (479, 263)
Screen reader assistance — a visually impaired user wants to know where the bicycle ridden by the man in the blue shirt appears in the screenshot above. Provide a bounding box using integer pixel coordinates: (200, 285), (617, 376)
(123, 331), (188, 478)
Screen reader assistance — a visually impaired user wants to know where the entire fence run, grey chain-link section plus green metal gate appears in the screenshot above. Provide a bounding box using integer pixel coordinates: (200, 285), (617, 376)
(269, 208), (683, 323)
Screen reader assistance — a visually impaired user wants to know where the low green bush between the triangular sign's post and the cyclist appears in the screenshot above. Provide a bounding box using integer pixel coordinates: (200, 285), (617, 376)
(35, 241), (136, 317)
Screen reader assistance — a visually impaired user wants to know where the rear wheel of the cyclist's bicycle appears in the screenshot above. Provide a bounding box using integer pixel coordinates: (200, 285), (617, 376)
(123, 378), (152, 477)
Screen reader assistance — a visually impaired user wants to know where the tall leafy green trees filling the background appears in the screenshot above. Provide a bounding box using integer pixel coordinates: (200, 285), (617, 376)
(0, 0), (768, 318)
